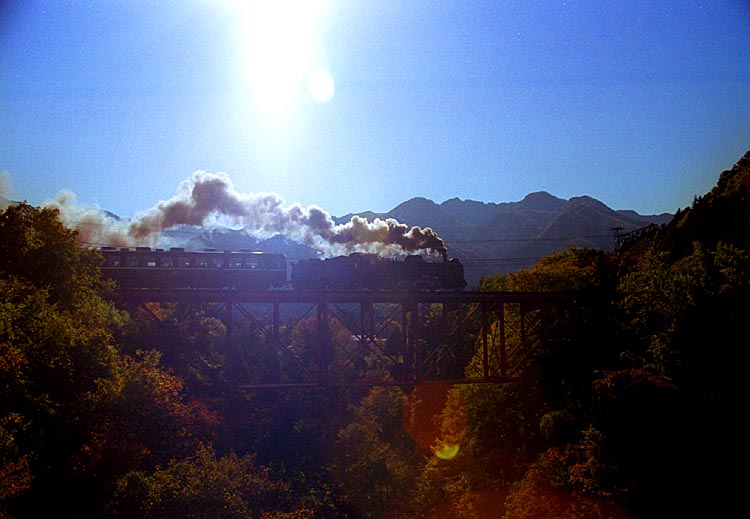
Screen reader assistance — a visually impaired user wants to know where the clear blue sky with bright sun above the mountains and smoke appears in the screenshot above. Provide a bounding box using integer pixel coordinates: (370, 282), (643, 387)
(0, 0), (750, 220)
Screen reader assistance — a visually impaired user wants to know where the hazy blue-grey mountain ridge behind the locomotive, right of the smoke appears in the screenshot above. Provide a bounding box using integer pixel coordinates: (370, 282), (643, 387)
(334, 191), (674, 285)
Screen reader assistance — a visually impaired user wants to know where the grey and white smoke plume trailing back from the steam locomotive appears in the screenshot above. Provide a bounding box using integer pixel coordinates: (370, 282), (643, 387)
(50, 171), (445, 256)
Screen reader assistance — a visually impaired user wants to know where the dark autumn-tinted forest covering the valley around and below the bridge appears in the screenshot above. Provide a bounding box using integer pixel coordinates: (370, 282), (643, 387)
(0, 152), (750, 519)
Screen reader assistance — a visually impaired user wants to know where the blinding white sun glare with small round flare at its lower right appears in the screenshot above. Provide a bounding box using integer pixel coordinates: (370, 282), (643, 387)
(236, 0), (334, 118)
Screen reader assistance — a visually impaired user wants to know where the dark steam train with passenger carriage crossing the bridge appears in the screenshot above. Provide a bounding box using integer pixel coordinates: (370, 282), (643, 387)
(100, 247), (466, 291)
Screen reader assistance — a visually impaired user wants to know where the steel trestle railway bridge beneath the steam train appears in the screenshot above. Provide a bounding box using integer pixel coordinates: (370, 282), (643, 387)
(118, 289), (577, 388)
